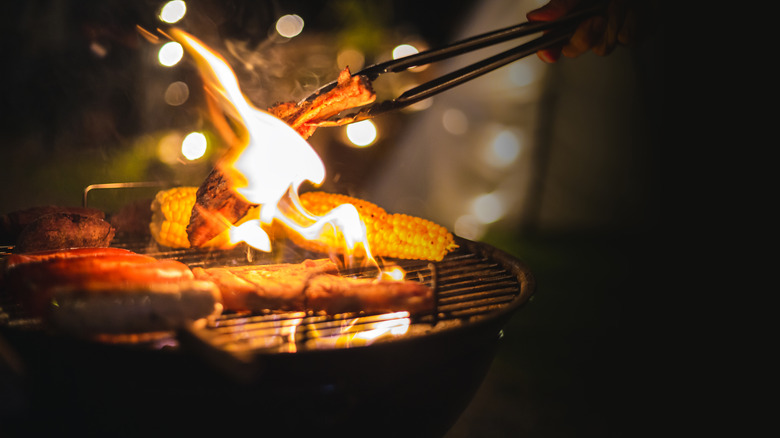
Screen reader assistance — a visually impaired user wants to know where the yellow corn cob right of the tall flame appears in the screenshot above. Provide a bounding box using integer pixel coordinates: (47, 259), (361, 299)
(288, 191), (457, 261)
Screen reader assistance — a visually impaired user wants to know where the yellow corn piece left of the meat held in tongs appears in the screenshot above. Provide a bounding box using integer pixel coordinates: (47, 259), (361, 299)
(149, 187), (235, 248)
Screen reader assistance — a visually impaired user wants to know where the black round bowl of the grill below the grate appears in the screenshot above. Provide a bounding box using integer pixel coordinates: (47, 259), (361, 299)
(0, 239), (535, 437)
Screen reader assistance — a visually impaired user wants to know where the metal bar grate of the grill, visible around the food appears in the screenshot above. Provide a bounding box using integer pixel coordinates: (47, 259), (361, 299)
(0, 239), (527, 352)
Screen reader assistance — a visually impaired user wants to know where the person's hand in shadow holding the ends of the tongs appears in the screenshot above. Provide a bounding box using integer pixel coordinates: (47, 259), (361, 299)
(526, 0), (649, 63)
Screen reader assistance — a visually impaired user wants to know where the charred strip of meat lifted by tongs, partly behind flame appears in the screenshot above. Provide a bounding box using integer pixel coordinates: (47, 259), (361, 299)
(187, 68), (376, 247)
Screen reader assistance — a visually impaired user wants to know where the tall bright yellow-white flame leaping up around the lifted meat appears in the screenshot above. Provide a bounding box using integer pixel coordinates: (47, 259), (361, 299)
(169, 28), (378, 266)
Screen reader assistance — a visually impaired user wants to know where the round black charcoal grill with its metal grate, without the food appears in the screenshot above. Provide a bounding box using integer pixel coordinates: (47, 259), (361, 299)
(0, 238), (535, 437)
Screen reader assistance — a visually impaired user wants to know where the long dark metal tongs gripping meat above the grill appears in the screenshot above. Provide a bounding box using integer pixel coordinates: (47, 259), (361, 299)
(303, 2), (604, 126)
